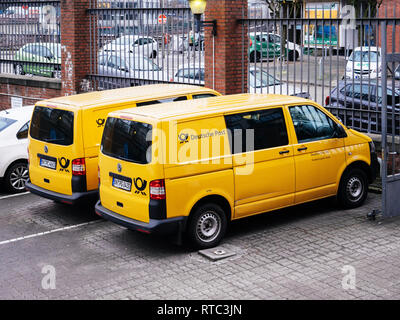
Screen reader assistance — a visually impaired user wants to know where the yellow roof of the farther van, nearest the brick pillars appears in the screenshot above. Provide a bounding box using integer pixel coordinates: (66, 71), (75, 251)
(38, 84), (219, 109)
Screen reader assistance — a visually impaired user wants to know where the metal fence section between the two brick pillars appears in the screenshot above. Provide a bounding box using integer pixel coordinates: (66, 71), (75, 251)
(88, 1), (204, 90)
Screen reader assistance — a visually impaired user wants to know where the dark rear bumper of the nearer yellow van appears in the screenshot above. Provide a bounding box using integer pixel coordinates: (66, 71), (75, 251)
(95, 201), (187, 235)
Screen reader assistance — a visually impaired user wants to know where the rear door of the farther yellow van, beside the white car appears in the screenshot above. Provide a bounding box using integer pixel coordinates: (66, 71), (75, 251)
(29, 106), (83, 195)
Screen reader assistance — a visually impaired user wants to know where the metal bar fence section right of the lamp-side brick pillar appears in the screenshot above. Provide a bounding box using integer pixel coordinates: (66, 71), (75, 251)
(241, 2), (400, 138)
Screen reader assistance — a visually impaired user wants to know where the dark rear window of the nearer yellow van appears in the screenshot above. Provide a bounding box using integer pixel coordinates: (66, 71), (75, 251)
(101, 117), (153, 164)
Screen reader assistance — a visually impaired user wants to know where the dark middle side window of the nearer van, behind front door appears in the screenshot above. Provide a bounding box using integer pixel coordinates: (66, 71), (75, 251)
(225, 108), (289, 154)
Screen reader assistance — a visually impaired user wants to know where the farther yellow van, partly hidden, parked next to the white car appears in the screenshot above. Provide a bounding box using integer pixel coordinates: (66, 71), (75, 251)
(26, 84), (220, 204)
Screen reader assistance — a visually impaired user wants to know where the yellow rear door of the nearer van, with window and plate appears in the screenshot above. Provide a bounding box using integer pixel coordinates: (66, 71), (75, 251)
(99, 117), (165, 223)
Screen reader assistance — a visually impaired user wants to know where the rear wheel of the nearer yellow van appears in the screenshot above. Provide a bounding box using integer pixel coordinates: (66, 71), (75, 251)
(187, 203), (227, 249)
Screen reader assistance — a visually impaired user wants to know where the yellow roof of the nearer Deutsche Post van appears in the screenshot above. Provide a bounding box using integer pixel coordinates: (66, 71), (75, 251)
(110, 93), (312, 120)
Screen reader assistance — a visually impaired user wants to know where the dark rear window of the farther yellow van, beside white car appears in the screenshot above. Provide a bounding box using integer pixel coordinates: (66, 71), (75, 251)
(30, 106), (74, 146)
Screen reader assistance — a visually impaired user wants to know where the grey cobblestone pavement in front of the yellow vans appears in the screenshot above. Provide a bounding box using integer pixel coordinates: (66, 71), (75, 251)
(0, 190), (400, 300)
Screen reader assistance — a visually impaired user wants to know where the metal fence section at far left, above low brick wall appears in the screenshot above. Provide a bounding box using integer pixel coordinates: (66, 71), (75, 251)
(0, 0), (61, 79)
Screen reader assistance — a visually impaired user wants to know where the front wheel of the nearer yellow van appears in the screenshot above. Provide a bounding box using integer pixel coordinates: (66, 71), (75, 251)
(338, 168), (368, 209)
